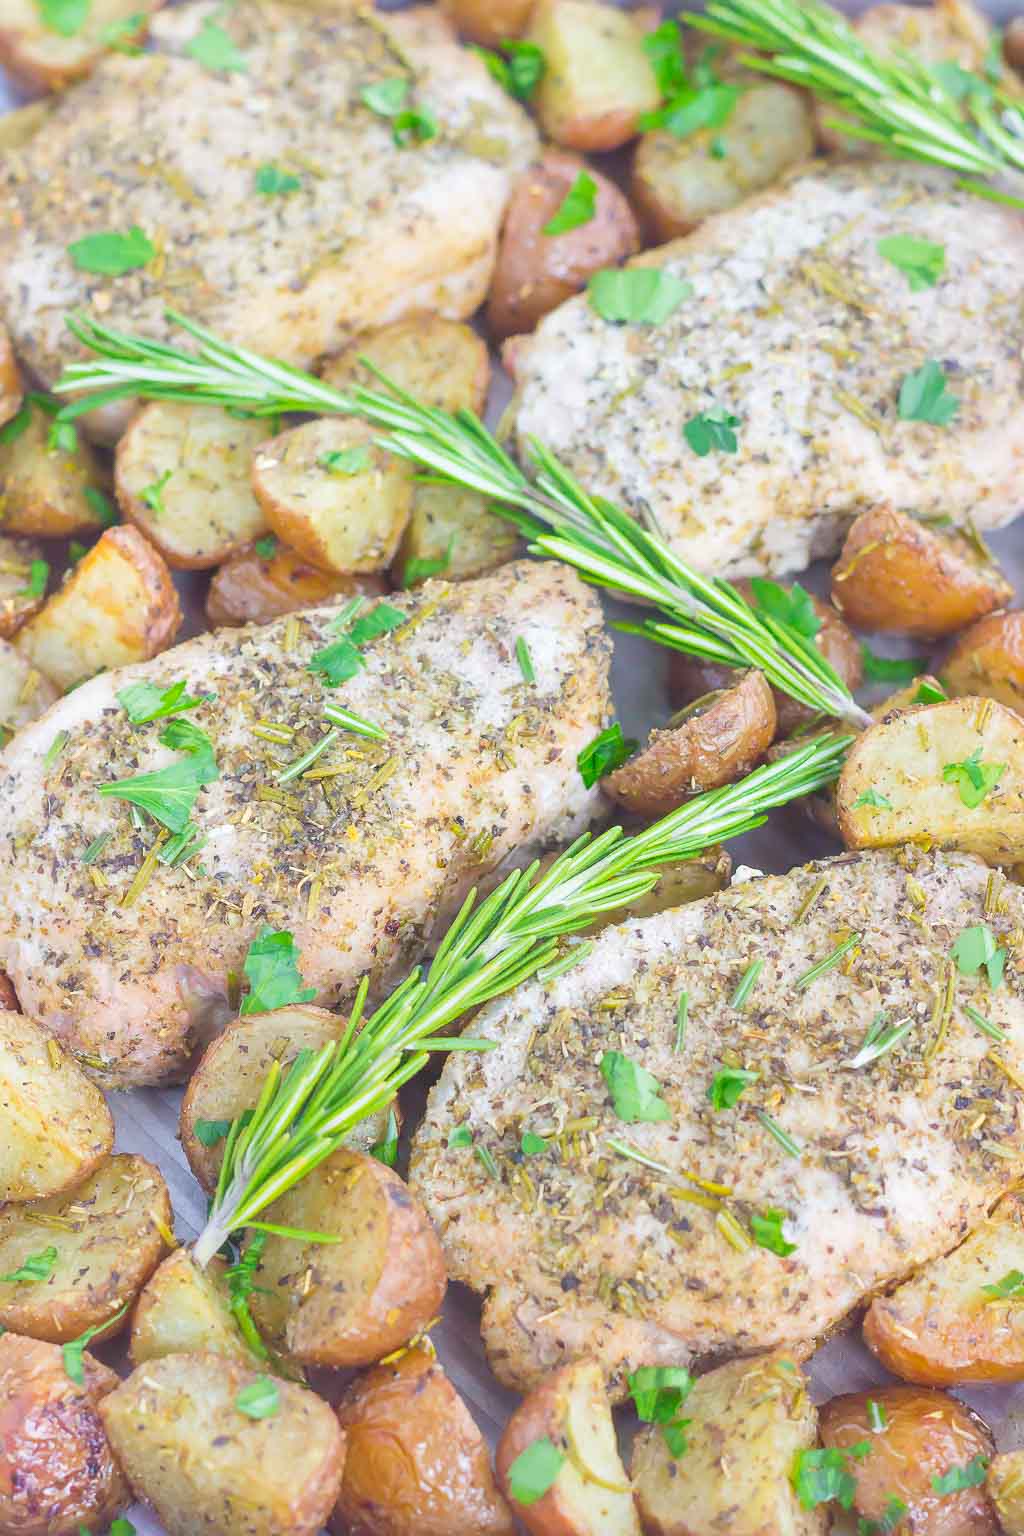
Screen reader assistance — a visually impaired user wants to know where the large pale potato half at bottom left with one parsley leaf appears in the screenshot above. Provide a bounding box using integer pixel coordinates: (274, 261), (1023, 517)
(100, 1355), (345, 1536)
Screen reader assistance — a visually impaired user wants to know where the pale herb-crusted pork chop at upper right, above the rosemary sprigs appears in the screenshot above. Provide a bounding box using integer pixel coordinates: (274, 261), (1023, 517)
(511, 161), (1024, 578)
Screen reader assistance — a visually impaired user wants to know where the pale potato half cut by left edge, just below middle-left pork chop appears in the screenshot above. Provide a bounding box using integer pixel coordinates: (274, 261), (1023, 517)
(0, 1014), (114, 1201)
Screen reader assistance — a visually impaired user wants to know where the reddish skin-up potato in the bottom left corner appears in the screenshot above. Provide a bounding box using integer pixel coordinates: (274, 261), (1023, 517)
(0, 1333), (129, 1536)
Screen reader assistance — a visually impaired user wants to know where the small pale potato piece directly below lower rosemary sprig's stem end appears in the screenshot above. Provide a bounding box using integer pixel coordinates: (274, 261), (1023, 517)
(129, 1247), (258, 1367)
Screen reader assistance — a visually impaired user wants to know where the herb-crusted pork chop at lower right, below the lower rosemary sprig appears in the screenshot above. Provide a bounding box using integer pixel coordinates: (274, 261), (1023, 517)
(411, 848), (1024, 1390)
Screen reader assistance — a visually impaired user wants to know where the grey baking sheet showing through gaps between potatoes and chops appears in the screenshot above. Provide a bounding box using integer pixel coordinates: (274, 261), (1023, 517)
(0, 0), (1024, 1536)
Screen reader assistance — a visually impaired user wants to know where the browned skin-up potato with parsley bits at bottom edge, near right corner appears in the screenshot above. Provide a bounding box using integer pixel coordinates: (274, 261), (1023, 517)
(818, 1387), (999, 1536)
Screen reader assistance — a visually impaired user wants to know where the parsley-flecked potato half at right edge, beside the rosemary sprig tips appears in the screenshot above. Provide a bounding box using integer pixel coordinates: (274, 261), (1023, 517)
(835, 699), (1024, 863)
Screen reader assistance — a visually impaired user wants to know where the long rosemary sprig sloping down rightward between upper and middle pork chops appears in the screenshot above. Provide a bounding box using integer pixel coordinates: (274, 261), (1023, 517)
(57, 310), (872, 728)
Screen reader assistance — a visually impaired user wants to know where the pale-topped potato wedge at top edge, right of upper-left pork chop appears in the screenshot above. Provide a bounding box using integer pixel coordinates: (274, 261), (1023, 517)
(527, 0), (660, 151)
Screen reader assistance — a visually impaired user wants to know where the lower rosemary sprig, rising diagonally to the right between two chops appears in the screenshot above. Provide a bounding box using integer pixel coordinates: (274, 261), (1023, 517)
(195, 736), (851, 1264)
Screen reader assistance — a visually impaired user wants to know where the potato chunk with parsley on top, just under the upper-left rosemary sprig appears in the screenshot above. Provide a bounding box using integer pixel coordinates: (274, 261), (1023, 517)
(252, 416), (413, 574)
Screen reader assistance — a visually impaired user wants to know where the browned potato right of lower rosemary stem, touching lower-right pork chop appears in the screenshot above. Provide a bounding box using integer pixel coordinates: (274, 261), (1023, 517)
(250, 1147), (447, 1367)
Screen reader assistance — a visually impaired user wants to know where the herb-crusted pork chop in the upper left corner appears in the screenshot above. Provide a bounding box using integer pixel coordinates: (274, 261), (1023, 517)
(0, 0), (536, 382)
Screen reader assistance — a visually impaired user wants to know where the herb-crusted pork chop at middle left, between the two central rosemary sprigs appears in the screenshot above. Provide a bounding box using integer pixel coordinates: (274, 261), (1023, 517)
(0, 562), (609, 1086)
